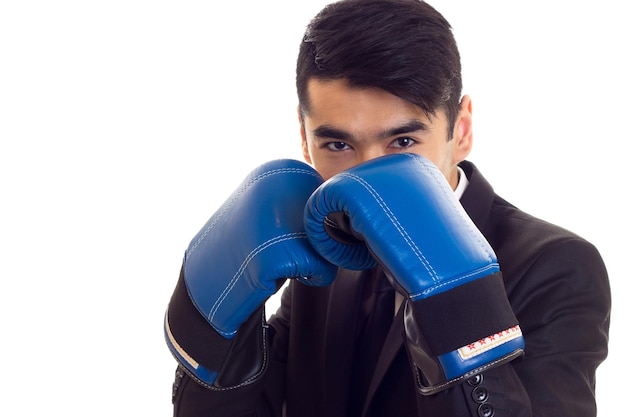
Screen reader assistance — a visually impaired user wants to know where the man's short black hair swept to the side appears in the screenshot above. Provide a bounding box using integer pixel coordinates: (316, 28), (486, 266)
(296, 0), (462, 138)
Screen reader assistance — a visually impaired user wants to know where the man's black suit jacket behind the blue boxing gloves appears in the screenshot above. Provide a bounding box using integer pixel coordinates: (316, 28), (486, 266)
(174, 162), (611, 417)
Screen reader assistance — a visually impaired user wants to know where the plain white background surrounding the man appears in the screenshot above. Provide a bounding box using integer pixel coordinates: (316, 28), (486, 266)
(0, 0), (626, 417)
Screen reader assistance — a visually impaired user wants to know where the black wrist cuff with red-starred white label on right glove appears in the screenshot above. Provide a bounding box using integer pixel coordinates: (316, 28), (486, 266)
(404, 272), (524, 394)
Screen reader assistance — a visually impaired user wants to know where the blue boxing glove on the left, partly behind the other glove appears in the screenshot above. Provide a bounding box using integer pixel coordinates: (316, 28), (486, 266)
(165, 160), (337, 389)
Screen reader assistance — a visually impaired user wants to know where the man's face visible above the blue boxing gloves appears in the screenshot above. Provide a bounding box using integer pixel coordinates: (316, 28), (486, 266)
(300, 79), (472, 188)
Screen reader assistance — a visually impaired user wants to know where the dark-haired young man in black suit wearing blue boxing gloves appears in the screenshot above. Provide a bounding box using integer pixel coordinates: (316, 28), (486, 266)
(165, 0), (610, 417)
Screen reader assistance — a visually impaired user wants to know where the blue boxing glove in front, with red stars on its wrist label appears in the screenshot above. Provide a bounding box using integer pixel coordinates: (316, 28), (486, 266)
(305, 154), (524, 394)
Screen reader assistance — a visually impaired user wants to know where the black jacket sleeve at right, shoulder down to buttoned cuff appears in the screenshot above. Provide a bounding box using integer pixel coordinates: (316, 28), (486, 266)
(416, 237), (611, 417)
